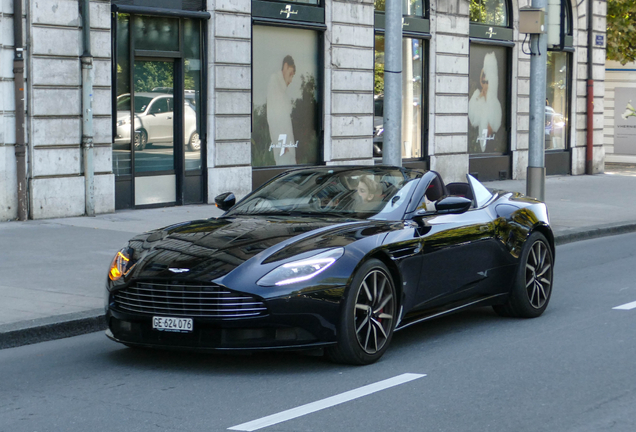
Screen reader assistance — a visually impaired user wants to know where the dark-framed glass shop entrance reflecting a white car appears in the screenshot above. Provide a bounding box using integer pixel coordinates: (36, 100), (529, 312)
(113, 14), (205, 209)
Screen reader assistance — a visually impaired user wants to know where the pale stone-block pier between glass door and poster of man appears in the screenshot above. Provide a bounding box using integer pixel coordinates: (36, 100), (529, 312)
(207, 0), (252, 203)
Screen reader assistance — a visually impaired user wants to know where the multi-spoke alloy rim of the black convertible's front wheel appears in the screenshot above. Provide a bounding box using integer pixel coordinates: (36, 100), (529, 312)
(354, 269), (395, 354)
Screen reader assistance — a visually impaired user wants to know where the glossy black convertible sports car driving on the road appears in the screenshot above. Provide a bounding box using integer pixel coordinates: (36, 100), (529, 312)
(106, 166), (554, 364)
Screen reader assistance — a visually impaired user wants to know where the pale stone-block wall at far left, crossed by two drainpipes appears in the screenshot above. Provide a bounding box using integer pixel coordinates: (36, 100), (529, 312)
(0, 0), (115, 220)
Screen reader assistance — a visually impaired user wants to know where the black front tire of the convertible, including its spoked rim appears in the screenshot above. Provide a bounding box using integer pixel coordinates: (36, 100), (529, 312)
(325, 259), (398, 365)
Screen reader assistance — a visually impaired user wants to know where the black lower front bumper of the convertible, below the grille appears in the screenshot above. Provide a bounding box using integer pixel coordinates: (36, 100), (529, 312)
(106, 290), (344, 351)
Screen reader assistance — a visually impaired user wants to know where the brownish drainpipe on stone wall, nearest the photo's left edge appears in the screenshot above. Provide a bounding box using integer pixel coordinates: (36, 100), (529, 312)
(13, 0), (29, 221)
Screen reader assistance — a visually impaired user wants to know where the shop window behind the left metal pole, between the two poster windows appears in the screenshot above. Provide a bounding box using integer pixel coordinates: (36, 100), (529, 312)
(373, 0), (430, 159)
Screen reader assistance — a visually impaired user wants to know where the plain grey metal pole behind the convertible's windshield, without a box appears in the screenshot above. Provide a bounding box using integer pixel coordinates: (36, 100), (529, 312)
(382, 0), (402, 166)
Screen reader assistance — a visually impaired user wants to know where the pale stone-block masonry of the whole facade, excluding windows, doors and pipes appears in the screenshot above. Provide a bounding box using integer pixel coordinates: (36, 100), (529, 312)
(0, 0), (609, 220)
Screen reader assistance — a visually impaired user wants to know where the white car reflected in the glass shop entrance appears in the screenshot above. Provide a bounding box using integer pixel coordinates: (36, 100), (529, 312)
(115, 92), (201, 151)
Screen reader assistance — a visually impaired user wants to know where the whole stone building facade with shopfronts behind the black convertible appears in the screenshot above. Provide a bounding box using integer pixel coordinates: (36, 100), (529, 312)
(0, 0), (606, 220)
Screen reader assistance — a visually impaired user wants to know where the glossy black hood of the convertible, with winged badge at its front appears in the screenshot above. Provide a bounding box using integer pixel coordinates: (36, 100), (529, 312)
(121, 216), (386, 282)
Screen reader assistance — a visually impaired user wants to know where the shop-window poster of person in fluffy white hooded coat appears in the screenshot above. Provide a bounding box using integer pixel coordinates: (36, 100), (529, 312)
(468, 45), (507, 154)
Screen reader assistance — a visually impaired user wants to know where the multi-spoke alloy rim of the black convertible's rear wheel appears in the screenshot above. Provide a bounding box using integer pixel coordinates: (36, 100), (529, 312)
(526, 241), (552, 309)
